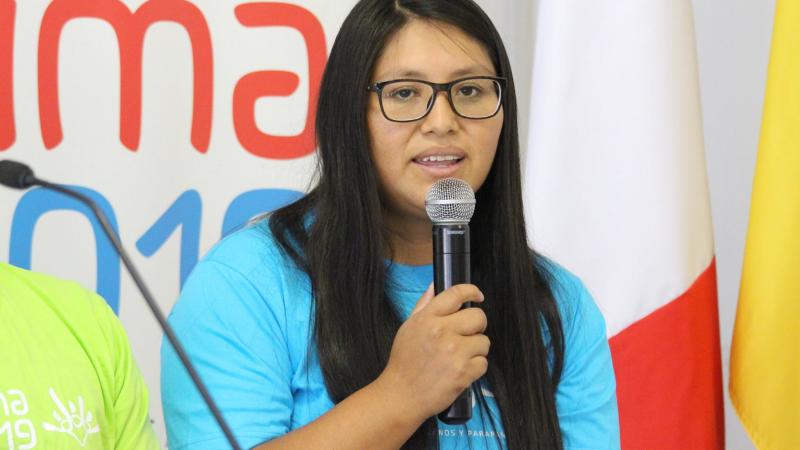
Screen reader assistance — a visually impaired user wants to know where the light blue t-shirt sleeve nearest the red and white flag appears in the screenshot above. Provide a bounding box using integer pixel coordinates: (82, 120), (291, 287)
(556, 278), (620, 450)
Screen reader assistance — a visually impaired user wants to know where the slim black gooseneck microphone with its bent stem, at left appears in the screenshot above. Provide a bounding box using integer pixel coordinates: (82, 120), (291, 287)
(0, 160), (241, 450)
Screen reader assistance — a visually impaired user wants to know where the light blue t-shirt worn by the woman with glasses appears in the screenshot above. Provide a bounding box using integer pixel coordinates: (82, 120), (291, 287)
(161, 222), (619, 450)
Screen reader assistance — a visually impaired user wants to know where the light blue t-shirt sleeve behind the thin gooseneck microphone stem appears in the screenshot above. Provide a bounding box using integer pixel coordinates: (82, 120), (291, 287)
(161, 258), (293, 450)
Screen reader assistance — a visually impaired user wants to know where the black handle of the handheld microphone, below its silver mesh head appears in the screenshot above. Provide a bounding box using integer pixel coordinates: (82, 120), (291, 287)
(433, 223), (472, 425)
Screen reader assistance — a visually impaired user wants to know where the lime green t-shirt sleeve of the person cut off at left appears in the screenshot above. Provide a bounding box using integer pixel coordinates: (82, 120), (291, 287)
(90, 293), (161, 450)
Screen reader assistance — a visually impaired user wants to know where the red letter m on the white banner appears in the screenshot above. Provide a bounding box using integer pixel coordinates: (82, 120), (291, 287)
(39, 0), (214, 153)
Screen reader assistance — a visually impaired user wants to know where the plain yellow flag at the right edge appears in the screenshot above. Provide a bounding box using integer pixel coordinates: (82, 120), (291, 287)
(730, 0), (800, 450)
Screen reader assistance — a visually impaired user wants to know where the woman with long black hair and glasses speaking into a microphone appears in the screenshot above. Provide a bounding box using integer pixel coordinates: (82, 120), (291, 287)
(162, 0), (619, 450)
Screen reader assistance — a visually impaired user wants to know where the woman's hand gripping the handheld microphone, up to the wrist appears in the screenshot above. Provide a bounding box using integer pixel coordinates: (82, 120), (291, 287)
(376, 284), (489, 421)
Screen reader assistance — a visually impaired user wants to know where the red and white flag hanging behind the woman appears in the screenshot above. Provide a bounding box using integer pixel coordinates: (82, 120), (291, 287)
(525, 0), (724, 450)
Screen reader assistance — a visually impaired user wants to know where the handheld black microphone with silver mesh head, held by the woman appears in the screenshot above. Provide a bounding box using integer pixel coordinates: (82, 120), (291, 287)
(425, 178), (475, 425)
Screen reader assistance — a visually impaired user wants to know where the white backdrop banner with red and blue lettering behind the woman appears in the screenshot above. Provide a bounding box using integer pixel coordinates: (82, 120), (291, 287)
(0, 0), (355, 439)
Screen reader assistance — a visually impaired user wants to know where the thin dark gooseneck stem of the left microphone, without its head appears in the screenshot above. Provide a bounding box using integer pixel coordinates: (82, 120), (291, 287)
(25, 175), (241, 450)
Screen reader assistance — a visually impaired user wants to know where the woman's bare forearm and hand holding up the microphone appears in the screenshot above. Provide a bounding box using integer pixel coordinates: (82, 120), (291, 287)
(256, 285), (489, 450)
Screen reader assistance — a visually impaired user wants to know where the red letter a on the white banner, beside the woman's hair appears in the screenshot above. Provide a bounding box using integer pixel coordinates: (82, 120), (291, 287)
(233, 3), (327, 159)
